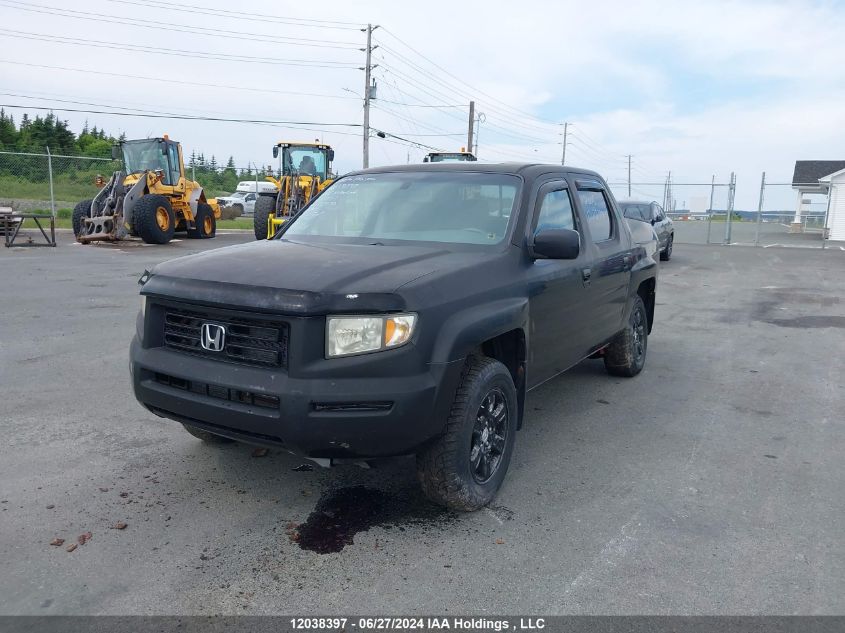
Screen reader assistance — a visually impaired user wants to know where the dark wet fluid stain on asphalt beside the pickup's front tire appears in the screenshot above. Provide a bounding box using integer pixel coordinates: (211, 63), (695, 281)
(290, 486), (456, 554)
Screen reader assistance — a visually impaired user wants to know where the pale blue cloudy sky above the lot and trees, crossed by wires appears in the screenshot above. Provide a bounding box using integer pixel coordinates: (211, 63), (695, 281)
(0, 0), (845, 207)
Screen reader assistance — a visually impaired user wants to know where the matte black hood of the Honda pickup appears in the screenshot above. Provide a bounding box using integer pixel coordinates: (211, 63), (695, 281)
(142, 240), (494, 315)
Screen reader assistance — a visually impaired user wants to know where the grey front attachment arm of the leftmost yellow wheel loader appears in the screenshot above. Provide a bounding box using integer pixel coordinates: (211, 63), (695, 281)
(76, 171), (146, 244)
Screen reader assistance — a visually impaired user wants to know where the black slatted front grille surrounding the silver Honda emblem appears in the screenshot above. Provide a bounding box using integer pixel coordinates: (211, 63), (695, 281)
(164, 307), (288, 368)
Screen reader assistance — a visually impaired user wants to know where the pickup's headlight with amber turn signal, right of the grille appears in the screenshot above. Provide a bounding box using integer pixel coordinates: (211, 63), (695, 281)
(326, 314), (417, 358)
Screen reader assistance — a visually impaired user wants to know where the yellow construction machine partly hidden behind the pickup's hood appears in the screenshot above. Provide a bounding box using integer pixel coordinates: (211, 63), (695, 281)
(253, 141), (334, 240)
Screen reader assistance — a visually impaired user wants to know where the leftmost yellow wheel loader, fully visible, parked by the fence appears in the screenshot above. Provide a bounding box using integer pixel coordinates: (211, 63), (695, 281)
(73, 134), (220, 244)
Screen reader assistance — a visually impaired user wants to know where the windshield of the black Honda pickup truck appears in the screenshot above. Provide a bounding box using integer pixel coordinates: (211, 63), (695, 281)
(282, 172), (521, 245)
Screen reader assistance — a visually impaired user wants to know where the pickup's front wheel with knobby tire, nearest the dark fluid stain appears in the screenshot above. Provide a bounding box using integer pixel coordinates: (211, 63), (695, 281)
(417, 356), (518, 512)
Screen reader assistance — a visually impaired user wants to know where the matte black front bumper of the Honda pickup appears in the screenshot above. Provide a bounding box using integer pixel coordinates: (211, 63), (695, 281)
(130, 336), (463, 458)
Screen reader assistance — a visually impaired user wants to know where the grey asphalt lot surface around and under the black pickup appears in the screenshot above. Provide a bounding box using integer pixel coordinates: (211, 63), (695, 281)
(0, 233), (845, 615)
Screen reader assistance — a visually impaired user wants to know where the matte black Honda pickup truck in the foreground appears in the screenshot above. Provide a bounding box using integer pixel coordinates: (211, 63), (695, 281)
(130, 163), (657, 510)
